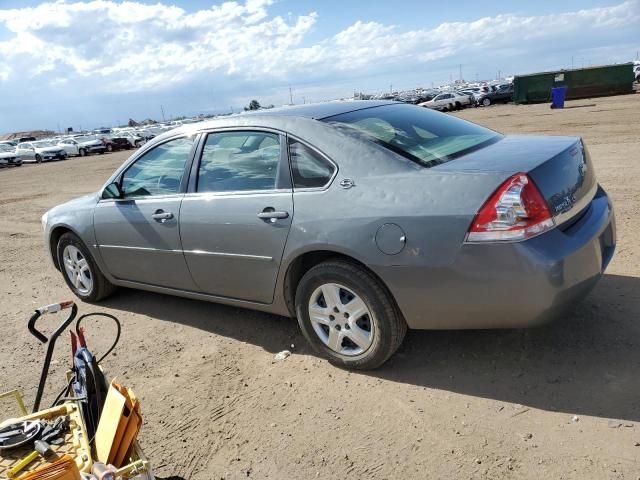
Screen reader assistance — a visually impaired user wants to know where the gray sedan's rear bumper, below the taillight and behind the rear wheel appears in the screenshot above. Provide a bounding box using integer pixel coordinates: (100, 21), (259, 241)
(378, 189), (616, 329)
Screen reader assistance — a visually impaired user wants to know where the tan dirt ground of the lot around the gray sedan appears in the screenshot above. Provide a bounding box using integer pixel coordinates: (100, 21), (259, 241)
(0, 94), (640, 480)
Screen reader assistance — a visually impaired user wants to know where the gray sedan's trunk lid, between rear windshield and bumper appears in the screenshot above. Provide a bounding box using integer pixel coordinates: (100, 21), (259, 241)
(433, 135), (597, 224)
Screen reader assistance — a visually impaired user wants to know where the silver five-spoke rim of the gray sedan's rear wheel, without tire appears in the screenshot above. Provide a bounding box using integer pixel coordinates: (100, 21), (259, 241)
(309, 283), (375, 356)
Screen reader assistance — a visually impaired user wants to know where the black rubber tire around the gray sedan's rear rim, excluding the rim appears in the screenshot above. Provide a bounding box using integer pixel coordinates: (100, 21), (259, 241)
(295, 260), (407, 370)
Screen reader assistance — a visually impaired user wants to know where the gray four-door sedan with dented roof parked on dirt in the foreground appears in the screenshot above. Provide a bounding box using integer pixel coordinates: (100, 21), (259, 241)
(42, 101), (616, 368)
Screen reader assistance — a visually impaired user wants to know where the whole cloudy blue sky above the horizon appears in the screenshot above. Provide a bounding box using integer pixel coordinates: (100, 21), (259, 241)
(0, 0), (640, 133)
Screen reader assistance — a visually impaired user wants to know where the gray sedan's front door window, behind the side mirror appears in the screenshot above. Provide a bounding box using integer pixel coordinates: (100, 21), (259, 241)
(121, 138), (194, 198)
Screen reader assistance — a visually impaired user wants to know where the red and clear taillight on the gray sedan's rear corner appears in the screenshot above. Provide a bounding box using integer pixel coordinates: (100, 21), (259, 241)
(466, 173), (554, 242)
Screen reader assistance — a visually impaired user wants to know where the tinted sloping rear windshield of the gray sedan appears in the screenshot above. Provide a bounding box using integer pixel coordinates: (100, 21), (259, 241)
(323, 104), (502, 167)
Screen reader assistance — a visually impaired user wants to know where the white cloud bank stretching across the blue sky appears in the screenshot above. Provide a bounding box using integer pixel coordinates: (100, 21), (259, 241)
(0, 0), (640, 129)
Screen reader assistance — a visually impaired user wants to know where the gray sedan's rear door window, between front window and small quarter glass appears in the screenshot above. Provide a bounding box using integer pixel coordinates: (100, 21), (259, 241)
(196, 132), (280, 192)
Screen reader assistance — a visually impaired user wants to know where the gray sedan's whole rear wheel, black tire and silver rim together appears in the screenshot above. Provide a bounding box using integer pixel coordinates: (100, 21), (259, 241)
(295, 260), (407, 370)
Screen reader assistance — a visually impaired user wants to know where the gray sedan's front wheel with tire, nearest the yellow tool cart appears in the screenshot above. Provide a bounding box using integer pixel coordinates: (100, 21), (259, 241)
(57, 232), (115, 302)
